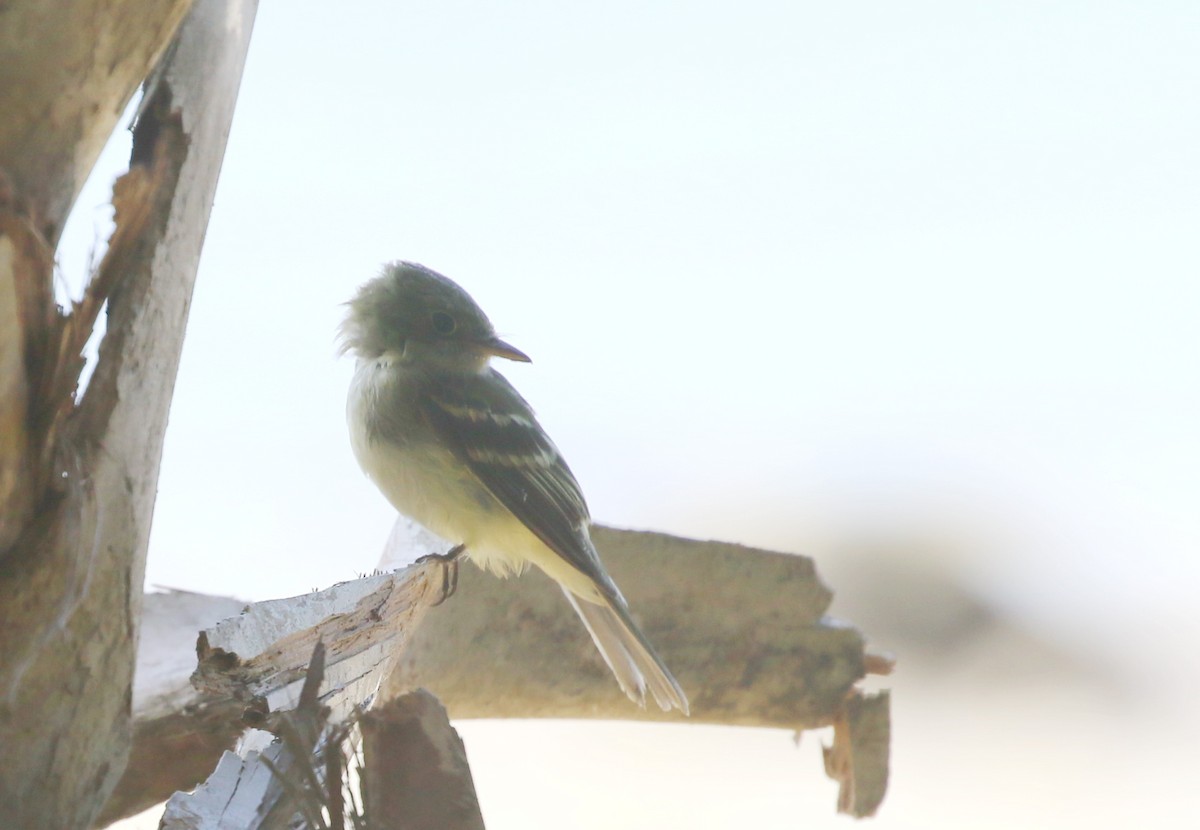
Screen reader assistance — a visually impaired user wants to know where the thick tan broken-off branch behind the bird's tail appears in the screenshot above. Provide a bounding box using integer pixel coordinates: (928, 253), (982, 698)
(388, 527), (866, 729)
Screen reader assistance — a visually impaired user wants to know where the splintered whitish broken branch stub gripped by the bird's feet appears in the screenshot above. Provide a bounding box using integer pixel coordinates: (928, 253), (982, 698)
(103, 561), (444, 826)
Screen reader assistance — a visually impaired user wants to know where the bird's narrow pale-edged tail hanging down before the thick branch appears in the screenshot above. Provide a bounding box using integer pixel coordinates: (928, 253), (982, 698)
(563, 588), (688, 715)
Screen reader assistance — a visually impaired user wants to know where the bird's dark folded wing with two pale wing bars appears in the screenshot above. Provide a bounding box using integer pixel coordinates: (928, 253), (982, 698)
(421, 369), (609, 596)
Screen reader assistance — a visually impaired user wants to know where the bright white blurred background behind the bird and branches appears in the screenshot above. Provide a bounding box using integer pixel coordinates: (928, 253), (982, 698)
(68, 0), (1200, 830)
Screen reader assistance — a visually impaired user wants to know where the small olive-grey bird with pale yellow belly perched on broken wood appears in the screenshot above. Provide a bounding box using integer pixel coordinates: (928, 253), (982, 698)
(341, 261), (688, 715)
